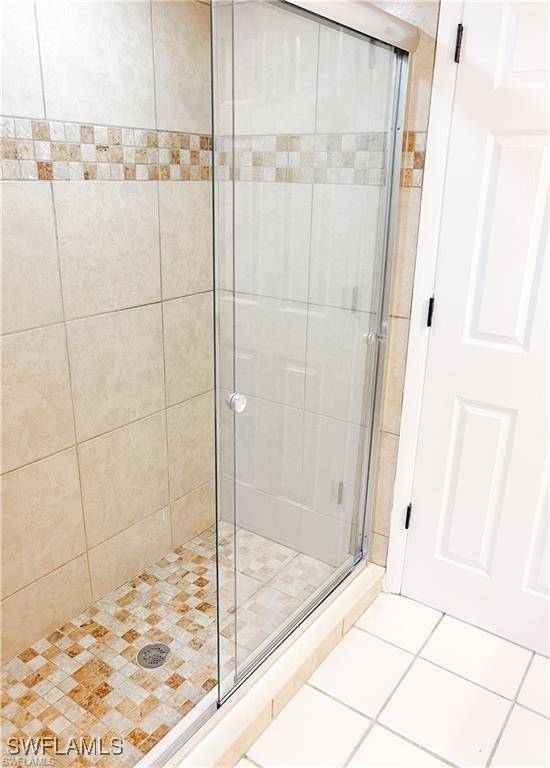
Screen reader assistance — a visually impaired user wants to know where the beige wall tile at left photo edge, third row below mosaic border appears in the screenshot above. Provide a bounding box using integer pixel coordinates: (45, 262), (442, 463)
(2, 448), (86, 597)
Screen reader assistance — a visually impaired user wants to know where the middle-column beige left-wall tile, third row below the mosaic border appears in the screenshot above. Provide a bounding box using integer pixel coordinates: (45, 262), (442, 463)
(78, 412), (168, 547)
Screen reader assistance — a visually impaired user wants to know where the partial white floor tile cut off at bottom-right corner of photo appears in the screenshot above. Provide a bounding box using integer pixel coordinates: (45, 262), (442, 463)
(491, 706), (550, 768)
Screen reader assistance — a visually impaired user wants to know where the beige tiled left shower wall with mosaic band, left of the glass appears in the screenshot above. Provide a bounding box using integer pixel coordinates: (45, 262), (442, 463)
(0, 0), (214, 658)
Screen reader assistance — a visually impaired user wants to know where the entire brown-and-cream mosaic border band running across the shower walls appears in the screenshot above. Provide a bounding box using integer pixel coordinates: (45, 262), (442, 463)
(0, 116), (426, 187)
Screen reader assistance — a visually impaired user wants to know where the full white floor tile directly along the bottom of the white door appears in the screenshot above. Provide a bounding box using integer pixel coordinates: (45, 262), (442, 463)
(421, 616), (531, 699)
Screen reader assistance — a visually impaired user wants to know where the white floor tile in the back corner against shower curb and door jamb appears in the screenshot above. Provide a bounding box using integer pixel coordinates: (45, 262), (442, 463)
(357, 592), (441, 653)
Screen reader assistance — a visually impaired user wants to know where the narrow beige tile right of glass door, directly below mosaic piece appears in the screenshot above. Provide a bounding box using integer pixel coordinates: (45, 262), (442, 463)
(390, 187), (422, 317)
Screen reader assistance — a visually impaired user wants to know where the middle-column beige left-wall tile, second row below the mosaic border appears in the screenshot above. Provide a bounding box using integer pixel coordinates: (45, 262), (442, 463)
(67, 304), (164, 440)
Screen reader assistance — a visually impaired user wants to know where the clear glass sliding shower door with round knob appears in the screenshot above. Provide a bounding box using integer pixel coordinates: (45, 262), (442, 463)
(213, 2), (408, 699)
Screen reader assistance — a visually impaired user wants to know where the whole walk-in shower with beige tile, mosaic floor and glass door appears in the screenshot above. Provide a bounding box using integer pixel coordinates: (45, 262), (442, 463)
(0, 0), (415, 766)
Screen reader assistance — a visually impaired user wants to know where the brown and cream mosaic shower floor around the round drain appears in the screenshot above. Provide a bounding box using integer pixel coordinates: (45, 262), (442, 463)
(1, 524), (333, 768)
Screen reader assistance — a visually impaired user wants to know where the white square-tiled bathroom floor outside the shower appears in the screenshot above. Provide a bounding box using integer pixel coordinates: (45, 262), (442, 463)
(243, 594), (550, 768)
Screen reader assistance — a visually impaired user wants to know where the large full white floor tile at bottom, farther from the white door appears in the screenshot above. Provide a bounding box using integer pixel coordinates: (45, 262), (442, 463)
(380, 659), (510, 768)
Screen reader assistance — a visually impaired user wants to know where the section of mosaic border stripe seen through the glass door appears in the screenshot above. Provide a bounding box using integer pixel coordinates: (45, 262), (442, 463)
(215, 133), (388, 186)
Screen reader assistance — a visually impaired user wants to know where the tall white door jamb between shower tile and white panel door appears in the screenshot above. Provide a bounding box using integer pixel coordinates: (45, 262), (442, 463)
(384, 0), (467, 593)
